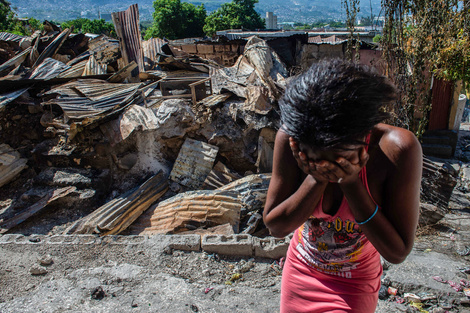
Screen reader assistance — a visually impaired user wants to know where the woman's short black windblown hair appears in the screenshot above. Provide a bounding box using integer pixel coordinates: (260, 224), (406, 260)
(279, 59), (396, 148)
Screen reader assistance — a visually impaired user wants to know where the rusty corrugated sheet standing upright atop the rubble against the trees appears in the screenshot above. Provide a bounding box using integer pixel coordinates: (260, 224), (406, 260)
(111, 4), (145, 72)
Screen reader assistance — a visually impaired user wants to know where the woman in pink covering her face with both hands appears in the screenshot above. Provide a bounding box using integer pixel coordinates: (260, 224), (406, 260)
(263, 60), (422, 313)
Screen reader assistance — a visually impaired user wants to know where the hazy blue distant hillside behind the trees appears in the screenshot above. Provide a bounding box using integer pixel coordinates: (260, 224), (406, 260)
(10, 0), (381, 23)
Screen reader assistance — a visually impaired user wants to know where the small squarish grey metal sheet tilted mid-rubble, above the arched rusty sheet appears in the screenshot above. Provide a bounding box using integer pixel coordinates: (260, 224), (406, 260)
(170, 138), (219, 189)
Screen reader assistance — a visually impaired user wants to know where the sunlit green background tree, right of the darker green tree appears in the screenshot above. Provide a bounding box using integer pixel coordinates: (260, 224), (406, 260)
(204, 0), (265, 36)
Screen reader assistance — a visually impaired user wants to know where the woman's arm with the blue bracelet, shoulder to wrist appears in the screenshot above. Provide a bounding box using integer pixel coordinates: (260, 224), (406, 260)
(340, 127), (422, 263)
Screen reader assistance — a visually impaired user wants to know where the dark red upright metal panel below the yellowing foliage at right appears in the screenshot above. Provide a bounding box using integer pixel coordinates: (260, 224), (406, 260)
(428, 78), (454, 130)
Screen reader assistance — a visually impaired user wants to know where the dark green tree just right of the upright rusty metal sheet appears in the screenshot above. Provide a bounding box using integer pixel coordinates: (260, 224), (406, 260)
(145, 0), (207, 39)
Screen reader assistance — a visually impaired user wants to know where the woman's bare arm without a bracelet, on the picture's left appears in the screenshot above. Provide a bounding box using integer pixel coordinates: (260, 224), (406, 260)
(263, 130), (327, 237)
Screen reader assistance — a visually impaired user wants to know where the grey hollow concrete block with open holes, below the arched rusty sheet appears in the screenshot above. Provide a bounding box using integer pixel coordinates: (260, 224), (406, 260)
(201, 234), (253, 256)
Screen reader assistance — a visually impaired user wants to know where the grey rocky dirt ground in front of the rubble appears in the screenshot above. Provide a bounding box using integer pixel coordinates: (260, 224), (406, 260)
(0, 124), (470, 313)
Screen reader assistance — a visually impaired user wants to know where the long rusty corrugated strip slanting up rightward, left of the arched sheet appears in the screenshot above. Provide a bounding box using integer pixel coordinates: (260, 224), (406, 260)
(66, 171), (168, 235)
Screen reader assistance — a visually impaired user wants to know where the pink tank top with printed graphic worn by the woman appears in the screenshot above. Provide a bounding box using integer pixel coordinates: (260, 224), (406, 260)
(293, 138), (382, 280)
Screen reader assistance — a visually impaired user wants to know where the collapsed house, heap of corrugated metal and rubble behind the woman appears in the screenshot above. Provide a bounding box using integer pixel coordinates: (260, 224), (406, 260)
(0, 5), (456, 237)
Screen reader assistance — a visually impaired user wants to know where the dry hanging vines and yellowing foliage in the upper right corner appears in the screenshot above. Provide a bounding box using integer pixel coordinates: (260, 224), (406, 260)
(382, 0), (470, 136)
